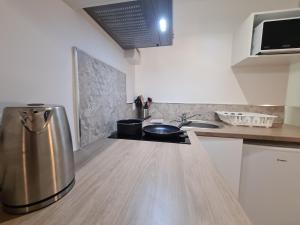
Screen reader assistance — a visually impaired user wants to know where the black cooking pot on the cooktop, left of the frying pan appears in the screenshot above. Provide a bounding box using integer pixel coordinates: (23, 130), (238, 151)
(117, 119), (143, 138)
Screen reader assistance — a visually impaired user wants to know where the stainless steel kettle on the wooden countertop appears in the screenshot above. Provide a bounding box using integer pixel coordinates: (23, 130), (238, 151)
(0, 104), (75, 214)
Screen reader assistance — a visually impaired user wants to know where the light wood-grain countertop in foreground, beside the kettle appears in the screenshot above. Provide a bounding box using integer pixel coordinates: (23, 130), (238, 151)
(0, 131), (251, 225)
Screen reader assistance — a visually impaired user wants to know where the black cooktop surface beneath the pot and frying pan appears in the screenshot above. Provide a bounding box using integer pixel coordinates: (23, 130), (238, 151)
(108, 131), (191, 144)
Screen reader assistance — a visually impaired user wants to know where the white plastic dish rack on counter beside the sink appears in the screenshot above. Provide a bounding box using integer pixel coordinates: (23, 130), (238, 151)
(216, 111), (278, 128)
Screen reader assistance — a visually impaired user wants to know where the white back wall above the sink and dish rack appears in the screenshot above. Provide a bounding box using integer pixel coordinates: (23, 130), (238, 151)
(135, 0), (298, 105)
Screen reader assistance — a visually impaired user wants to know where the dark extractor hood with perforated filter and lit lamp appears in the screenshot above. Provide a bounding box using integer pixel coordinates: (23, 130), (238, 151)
(84, 0), (173, 49)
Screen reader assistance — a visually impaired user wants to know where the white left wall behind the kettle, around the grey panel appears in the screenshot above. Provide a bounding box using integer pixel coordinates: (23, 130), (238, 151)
(0, 0), (134, 151)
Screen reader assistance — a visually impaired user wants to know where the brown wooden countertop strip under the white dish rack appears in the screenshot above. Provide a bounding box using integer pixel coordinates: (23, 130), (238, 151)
(193, 125), (300, 143)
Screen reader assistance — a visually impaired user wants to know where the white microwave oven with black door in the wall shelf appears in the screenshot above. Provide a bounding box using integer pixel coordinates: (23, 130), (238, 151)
(251, 17), (300, 55)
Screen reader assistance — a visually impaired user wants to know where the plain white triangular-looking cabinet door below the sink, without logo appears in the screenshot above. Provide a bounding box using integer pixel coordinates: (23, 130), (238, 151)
(199, 136), (243, 198)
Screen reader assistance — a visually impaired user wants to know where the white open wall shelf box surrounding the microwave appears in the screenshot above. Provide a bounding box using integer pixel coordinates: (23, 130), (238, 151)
(232, 8), (300, 67)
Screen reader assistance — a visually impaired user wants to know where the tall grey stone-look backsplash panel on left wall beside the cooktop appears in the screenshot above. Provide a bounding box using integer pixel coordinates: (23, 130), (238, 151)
(78, 50), (133, 147)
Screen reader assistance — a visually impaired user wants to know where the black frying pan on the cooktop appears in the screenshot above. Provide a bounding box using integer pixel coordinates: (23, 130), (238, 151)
(143, 124), (183, 138)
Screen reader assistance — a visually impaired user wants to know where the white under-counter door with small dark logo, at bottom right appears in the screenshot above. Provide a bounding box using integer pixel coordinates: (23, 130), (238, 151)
(240, 145), (300, 225)
